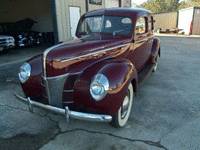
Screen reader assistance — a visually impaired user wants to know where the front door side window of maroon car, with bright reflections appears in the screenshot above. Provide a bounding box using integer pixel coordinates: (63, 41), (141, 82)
(135, 17), (147, 34)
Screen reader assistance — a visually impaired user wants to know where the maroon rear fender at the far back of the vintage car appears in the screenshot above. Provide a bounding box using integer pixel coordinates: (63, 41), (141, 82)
(150, 37), (160, 62)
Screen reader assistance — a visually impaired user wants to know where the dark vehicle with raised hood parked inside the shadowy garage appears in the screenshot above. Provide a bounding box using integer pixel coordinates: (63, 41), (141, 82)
(1, 18), (43, 46)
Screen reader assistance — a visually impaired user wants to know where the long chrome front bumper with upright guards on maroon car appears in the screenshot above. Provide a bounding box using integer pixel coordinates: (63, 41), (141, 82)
(15, 93), (112, 122)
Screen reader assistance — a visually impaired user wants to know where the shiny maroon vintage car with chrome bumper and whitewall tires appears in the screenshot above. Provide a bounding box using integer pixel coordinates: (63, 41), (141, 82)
(16, 8), (160, 127)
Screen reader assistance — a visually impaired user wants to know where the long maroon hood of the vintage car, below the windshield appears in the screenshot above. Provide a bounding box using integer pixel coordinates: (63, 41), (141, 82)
(43, 34), (130, 77)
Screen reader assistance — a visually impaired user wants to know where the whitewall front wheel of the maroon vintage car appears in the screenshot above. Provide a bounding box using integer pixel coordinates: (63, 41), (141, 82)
(110, 83), (133, 128)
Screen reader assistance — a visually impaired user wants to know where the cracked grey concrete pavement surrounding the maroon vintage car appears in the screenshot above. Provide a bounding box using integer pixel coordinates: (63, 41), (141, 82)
(0, 36), (200, 150)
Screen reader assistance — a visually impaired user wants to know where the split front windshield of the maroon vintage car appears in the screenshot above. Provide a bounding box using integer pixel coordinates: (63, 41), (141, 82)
(78, 16), (132, 35)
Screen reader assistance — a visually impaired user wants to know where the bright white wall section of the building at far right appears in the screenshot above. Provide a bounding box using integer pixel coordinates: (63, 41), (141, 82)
(178, 7), (194, 35)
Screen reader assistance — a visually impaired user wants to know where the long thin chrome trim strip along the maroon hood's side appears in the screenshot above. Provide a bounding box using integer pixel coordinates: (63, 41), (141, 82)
(61, 43), (131, 62)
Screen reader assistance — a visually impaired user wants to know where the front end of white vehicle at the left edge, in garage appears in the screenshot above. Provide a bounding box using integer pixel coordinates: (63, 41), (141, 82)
(0, 35), (15, 52)
